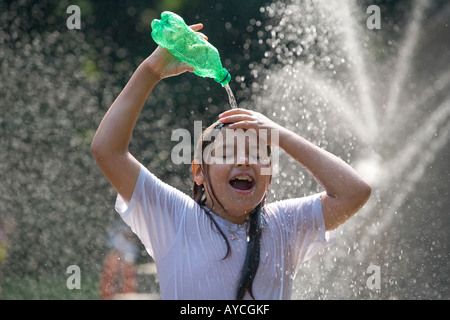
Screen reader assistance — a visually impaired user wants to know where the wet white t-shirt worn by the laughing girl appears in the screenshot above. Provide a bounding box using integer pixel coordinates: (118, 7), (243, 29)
(116, 166), (334, 300)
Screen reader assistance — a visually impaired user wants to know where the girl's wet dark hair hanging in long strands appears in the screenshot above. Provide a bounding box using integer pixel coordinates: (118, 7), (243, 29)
(192, 121), (270, 300)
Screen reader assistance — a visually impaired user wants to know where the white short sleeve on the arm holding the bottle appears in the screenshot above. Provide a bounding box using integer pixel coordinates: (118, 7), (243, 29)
(115, 166), (195, 261)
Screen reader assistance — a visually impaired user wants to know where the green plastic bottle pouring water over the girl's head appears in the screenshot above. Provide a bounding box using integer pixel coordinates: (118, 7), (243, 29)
(152, 11), (231, 86)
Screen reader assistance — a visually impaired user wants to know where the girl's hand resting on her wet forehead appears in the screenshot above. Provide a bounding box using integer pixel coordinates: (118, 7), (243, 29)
(219, 108), (284, 145)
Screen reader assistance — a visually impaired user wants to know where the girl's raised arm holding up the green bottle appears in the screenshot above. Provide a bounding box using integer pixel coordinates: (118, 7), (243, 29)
(91, 24), (206, 202)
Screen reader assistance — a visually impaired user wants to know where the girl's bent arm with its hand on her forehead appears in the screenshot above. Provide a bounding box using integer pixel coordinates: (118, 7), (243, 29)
(219, 109), (371, 230)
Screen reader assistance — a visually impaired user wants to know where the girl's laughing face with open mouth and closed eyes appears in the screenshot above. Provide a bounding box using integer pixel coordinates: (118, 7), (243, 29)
(193, 129), (272, 223)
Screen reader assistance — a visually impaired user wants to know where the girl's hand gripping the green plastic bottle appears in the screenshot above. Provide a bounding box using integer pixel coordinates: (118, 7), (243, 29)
(144, 23), (208, 79)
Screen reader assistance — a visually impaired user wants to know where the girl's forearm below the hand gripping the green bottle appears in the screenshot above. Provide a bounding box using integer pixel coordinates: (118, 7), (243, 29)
(91, 61), (160, 155)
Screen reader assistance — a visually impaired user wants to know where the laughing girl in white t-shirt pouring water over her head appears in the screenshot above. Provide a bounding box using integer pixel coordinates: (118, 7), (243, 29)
(91, 24), (370, 299)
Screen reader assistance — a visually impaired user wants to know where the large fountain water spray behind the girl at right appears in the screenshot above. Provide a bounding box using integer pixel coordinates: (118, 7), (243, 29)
(240, 0), (450, 299)
